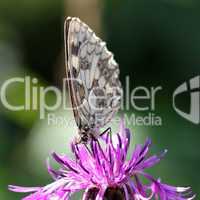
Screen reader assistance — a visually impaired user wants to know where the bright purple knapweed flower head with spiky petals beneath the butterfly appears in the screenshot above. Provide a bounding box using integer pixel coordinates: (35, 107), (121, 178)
(9, 121), (195, 200)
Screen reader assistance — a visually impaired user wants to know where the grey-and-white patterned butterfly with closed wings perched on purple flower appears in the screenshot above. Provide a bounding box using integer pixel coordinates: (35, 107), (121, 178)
(64, 17), (122, 143)
